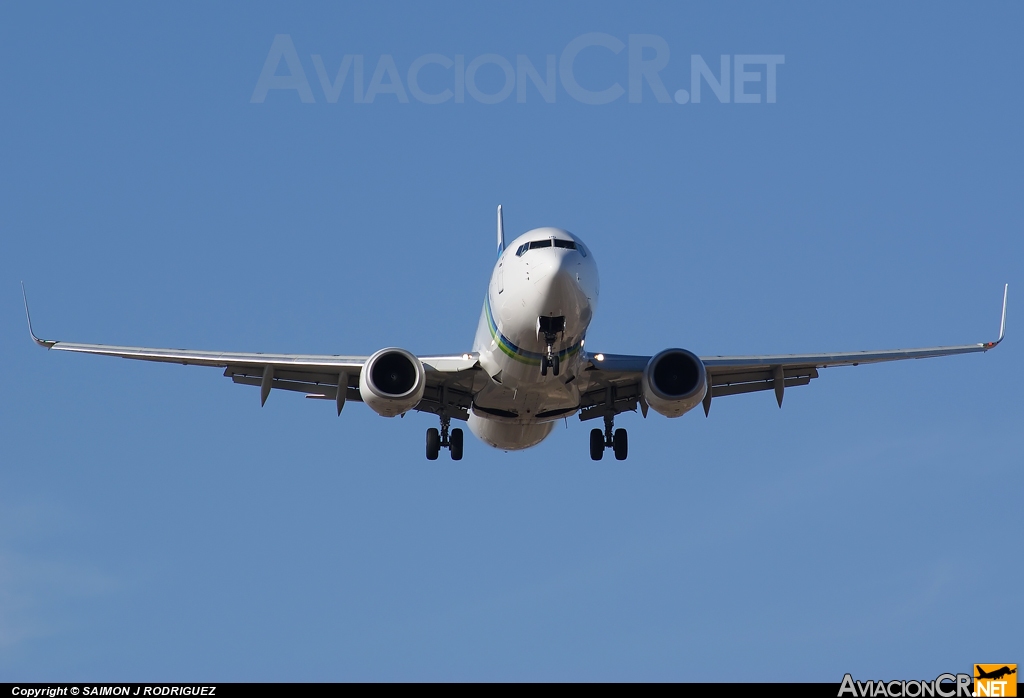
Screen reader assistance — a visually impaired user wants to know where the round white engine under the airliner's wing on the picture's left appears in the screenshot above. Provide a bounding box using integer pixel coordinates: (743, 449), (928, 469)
(359, 347), (427, 417)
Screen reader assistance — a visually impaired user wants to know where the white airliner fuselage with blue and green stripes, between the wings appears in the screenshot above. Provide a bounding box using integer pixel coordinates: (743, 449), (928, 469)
(469, 228), (600, 449)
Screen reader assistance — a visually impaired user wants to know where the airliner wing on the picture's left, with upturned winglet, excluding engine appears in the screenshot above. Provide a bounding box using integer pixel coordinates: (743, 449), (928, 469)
(25, 284), (482, 420)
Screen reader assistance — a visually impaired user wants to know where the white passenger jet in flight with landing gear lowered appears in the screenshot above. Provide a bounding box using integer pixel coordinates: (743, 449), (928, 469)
(22, 206), (1009, 461)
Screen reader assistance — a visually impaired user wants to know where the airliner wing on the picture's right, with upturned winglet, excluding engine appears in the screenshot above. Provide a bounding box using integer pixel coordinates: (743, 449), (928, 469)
(580, 285), (1009, 420)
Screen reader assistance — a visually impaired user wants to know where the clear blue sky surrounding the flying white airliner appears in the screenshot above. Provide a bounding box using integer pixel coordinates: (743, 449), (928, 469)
(0, 3), (1024, 682)
